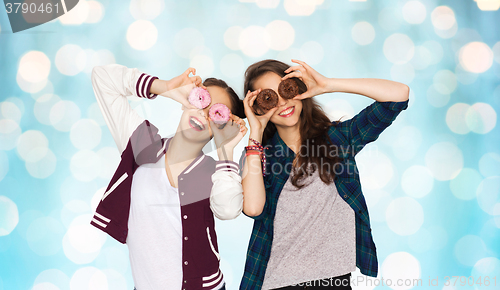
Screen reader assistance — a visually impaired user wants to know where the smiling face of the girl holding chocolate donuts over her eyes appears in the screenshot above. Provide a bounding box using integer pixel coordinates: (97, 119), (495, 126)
(254, 72), (302, 127)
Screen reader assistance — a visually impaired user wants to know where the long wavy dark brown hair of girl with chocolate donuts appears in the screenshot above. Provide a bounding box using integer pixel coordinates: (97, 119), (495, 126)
(244, 59), (342, 188)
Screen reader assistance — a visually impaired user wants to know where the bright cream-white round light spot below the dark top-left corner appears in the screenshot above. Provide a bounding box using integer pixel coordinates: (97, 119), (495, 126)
(18, 50), (50, 83)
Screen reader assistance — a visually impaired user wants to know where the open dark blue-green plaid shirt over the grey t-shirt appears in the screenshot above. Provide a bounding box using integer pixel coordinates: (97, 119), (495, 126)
(240, 100), (408, 290)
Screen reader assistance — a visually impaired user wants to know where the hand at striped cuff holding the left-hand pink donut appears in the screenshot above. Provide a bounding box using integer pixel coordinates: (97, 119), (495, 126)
(161, 67), (201, 109)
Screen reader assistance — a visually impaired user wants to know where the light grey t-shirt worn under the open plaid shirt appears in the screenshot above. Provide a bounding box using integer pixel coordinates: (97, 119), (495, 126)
(262, 170), (356, 290)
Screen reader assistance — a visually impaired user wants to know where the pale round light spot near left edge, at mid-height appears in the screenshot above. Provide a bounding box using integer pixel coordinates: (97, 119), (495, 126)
(17, 130), (49, 162)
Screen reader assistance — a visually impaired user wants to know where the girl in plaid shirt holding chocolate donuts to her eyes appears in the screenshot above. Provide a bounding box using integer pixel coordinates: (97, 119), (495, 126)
(240, 60), (409, 290)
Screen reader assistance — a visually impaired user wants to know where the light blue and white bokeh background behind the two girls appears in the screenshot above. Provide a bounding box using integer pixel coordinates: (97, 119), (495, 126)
(0, 0), (500, 290)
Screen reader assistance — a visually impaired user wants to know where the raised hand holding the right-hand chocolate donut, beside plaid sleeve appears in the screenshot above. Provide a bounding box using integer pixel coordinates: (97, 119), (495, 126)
(281, 59), (328, 100)
